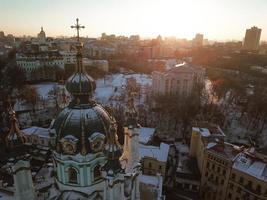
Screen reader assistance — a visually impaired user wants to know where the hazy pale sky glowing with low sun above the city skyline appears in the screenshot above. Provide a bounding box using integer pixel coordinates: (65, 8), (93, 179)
(0, 0), (267, 40)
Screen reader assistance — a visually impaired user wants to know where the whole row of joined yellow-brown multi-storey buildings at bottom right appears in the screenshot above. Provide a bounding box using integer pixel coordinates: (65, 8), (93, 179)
(190, 124), (267, 200)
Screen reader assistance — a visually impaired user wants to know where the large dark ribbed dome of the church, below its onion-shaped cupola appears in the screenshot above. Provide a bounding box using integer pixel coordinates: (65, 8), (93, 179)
(53, 103), (112, 154)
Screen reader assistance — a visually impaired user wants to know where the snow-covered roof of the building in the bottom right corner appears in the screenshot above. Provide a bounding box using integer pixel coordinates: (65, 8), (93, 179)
(233, 153), (267, 182)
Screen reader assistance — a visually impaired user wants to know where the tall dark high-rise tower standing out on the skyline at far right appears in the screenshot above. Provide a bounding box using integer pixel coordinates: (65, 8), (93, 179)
(243, 26), (261, 51)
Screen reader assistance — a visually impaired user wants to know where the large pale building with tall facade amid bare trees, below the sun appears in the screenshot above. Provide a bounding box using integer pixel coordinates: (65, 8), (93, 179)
(152, 64), (205, 96)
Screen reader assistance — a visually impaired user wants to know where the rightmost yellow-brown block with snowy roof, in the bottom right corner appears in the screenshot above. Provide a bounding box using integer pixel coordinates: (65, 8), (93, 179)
(226, 148), (267, 200)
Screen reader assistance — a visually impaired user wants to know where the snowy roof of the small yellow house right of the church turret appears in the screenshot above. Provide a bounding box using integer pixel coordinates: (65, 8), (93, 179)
(139, 143), (170, 162)
